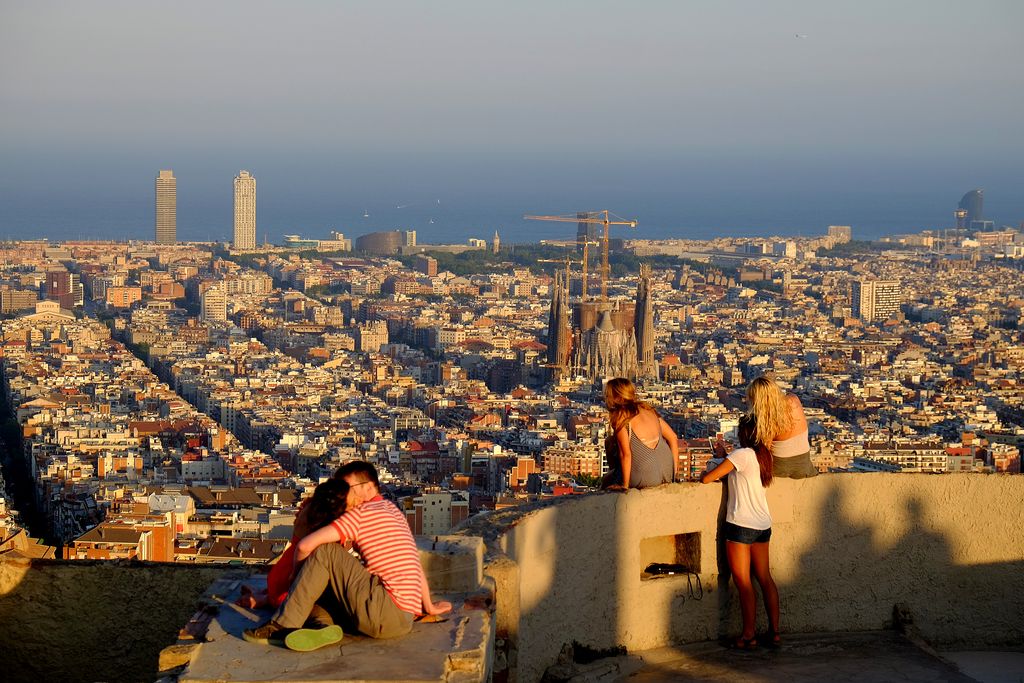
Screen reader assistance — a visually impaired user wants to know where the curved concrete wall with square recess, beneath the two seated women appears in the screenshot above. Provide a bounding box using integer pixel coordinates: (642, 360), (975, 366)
(475, 474), (1024, 681)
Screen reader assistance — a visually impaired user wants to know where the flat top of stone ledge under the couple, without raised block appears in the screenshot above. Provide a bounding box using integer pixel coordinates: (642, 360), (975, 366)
(179, 581), (494, 683)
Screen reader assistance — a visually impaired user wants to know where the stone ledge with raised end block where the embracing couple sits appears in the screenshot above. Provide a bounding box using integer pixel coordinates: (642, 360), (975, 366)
(161, 537), (495, 683)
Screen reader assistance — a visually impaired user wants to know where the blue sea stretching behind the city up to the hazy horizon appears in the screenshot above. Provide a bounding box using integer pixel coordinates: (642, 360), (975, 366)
(0, 160), (1024, 244)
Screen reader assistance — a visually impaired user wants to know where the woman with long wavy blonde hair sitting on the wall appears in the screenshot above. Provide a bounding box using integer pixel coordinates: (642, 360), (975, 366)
(746, 376), (818, 479)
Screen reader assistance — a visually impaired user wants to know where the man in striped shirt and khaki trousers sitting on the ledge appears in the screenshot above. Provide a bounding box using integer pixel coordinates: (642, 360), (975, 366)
(245, 461), (452, 651)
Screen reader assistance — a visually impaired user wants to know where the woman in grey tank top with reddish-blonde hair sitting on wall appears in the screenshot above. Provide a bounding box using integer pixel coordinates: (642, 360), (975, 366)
(604, 377), (679, 488)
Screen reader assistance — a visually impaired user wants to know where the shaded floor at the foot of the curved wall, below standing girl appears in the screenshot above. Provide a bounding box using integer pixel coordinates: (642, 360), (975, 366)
(628, 632), (977, 683)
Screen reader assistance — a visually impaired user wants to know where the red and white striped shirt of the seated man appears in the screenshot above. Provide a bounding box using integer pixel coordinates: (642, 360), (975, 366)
(332, 496), (424, 615)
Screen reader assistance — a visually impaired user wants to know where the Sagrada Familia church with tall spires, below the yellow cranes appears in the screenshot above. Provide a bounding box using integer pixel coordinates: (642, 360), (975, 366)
(548, 265), (657, 382)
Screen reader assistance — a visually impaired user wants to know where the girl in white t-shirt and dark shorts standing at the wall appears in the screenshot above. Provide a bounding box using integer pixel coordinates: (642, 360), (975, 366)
(700, 416), (780, 650)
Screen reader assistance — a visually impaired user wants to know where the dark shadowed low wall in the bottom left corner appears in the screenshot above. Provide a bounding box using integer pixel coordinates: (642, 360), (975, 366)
(0, 560), (227, 683)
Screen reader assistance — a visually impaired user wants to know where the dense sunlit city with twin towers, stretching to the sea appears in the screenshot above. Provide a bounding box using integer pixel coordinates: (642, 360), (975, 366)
(0, 170), (1024, 563)
